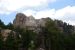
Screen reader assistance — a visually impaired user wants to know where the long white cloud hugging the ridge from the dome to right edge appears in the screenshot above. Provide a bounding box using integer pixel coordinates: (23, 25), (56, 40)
(23, 6), (75, 25)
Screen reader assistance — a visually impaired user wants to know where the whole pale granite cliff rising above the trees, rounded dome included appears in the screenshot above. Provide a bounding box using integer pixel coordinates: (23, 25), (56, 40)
(13, 13), (46, 30)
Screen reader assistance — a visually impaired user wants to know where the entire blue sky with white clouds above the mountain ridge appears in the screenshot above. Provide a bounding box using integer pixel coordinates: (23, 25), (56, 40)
(0, 0), (75, 25)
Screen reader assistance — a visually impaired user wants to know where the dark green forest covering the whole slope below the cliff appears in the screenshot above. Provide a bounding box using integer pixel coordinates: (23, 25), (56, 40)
(0, 18), (75, 50)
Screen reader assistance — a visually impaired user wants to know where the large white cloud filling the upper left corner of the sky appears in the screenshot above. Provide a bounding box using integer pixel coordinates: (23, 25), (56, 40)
(0, 0), (56, 12)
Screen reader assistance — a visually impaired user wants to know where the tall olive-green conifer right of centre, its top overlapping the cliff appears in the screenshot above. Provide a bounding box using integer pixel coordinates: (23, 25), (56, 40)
(42, 19), (61, 50)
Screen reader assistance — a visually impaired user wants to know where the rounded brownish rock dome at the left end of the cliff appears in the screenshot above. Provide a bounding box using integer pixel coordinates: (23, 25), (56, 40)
(13, 13), (27, 28)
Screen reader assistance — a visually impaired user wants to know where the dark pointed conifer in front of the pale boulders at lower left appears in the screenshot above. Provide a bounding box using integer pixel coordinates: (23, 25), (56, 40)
(5, 31), (17, 50)
